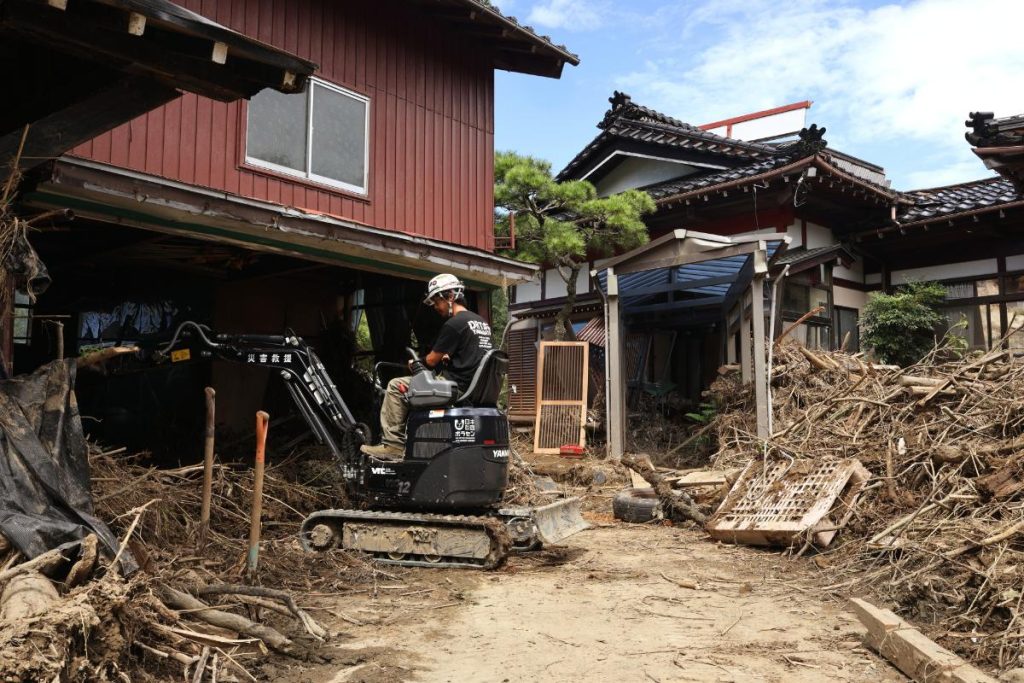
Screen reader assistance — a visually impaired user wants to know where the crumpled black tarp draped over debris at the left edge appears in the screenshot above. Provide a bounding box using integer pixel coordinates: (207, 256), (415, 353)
(0, 359), (135, 573)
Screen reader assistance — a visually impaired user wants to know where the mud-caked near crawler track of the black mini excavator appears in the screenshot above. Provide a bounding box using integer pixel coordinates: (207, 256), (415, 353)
(299, 510), (512, 569)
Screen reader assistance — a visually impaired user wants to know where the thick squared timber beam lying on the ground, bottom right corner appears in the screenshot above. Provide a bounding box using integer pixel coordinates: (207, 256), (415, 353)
(849, 598), (996, 683)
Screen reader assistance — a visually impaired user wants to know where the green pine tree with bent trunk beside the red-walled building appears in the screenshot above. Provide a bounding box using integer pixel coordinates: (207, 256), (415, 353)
(495, 152), (654, 340)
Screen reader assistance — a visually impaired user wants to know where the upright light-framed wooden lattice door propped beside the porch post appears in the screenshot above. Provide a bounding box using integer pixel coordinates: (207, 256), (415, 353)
(534, 342), (590, 453)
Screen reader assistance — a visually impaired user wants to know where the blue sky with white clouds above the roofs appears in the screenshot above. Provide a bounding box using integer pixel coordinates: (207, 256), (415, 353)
(496, 0), (1024, 189)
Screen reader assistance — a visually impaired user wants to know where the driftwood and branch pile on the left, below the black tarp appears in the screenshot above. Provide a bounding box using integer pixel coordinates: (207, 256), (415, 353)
(0, 452), (391, 683)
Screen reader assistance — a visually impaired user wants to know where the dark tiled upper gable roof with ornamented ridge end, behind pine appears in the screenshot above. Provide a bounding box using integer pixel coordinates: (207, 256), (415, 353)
(557, 92), (777, 180)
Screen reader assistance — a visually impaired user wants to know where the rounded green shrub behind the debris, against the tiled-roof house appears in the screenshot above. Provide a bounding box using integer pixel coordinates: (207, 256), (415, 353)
(860, 283), (946, 368)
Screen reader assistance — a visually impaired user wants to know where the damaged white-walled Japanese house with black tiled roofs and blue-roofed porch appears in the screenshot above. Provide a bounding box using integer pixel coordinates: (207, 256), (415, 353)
(509, 92), (1024, 454)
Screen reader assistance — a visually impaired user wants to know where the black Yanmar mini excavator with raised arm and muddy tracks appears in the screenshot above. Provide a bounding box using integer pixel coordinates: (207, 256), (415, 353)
(155, 321), (587, 569)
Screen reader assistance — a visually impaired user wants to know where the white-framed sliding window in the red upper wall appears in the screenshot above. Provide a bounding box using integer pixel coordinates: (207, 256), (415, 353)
(246, 79), (370, 195)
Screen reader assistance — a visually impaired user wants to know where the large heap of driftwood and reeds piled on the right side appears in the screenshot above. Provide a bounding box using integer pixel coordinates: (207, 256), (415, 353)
(712, 345), (1024, 669)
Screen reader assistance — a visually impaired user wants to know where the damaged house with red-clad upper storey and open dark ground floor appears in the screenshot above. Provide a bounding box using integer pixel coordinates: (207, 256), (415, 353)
(5, 0), (578, 454)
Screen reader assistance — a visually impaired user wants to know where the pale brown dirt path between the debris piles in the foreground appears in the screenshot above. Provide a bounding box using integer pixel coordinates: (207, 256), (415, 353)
(275, 523), (905, 683)
